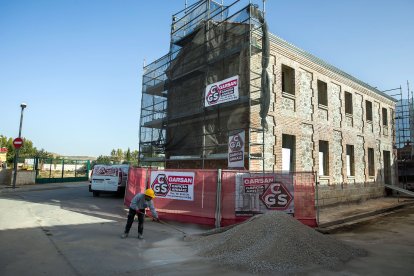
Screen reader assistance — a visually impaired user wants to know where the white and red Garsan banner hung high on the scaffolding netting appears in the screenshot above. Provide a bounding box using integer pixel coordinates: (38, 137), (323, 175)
(204, 76), (239, 107)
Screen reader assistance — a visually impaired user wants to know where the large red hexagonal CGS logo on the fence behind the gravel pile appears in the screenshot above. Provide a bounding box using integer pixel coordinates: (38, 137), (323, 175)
(260, 183), (293, 210)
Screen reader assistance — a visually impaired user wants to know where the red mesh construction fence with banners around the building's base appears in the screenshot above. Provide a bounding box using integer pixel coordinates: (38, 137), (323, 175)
(124, 168), (317, 227)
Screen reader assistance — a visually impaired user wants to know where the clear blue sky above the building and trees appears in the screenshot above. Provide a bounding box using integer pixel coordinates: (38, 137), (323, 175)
(0, 0), (414, 157)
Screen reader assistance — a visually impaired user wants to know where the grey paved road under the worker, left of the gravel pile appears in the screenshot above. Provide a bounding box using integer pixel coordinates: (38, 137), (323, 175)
(0, 185), (240, 276)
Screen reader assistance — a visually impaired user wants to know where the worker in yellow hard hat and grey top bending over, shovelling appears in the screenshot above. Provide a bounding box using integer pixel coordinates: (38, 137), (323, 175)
(121, 189), (159, 239)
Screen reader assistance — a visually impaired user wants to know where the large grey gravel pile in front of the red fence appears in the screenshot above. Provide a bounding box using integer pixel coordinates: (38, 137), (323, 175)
(195, 212), (366, 273)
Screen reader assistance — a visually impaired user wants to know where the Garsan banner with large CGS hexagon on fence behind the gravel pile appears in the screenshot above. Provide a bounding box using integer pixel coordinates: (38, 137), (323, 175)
(235, 173), (294, 216)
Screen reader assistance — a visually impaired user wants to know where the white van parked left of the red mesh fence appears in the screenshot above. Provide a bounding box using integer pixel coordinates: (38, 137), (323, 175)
(89, 165), (129, 196)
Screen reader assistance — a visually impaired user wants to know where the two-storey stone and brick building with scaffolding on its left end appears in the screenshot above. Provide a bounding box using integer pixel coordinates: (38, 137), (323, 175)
(140, 0), (396, 203)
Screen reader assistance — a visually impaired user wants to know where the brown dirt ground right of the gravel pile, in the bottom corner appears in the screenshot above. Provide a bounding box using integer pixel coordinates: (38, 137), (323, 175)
(315, 207), (414, 275)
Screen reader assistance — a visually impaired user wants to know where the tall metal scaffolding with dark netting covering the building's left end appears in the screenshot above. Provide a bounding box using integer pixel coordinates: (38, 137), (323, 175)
(139, 0), (267, 169)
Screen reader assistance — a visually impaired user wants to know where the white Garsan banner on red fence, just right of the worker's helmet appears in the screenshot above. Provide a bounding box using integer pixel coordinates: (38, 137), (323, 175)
(151, 171), (195, 200)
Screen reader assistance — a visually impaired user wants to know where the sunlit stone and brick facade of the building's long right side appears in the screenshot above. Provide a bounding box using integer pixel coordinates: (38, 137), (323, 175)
(249, 33), (395, 205)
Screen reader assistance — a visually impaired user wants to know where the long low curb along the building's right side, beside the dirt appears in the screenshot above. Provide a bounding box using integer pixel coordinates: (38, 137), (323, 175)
(315, 201), (414, 234)
